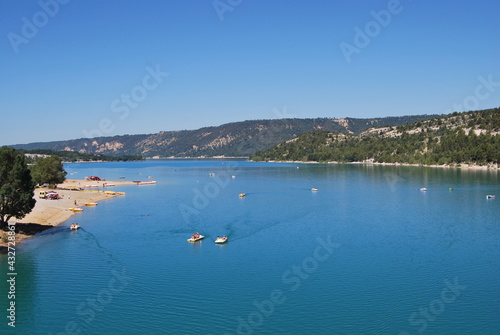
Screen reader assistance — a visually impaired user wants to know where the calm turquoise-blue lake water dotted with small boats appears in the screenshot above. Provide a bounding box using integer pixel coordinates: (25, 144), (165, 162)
(0, 160), (500, 335)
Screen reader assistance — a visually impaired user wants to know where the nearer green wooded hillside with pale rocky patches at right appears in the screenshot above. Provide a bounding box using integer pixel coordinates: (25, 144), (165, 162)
(252, 108), (500, 165)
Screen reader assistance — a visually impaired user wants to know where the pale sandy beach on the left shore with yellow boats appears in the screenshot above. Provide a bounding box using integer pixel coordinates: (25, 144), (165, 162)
(0, 179), (135, 247)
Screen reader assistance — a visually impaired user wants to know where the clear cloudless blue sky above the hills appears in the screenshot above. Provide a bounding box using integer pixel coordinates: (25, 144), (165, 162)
(0, 0), (500, 145)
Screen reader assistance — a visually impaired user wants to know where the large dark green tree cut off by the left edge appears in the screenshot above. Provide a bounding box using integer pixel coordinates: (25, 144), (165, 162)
(0, 147), (36, 229)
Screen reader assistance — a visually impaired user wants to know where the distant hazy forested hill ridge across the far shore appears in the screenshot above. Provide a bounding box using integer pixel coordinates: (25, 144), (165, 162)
(9, 115), (435, 157)
